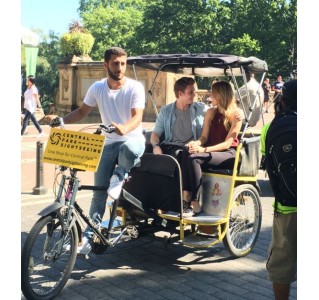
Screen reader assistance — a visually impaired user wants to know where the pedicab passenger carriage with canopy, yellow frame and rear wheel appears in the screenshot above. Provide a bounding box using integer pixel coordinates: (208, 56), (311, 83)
(123, 53), (268, 257)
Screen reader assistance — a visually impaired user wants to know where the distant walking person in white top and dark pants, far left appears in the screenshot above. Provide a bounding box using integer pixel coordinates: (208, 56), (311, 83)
(21, 75), (44, 138)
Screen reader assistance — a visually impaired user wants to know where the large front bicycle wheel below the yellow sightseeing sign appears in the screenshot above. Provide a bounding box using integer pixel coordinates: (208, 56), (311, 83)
(21, 214), (78, 300)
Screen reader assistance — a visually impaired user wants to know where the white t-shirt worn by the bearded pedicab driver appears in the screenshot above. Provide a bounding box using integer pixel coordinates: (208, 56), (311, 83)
(83, 77), (145, 144)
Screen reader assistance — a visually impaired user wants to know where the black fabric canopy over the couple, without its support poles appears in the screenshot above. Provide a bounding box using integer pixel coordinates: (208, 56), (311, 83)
(127, 53), (268, 77)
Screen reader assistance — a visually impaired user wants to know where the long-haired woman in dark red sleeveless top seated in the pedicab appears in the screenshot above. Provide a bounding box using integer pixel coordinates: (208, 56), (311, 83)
(181, 81), (242, 217)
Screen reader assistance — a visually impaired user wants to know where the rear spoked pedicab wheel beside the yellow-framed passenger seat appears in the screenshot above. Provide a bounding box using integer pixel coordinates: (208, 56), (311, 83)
(223, 184), (262, 257)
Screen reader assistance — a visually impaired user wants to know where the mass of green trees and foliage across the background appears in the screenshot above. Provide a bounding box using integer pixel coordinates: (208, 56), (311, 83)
(21, 0), (297, 105)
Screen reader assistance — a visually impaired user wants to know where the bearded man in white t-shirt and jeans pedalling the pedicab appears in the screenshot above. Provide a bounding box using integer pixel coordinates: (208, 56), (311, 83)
(47, 47), (145, 255)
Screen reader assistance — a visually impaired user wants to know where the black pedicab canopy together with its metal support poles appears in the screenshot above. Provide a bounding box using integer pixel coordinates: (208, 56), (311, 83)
(127, 53), (268, 133)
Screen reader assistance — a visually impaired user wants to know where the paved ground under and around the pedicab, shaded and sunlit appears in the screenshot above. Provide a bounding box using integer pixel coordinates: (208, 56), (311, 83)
(21, 104), (297, 300)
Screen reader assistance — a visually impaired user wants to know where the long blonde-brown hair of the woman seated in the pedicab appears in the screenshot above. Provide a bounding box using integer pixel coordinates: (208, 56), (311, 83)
(212, 80), (237, 129)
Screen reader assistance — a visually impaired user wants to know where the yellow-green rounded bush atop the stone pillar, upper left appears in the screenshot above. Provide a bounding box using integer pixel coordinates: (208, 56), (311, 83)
(61, 31), (94, 56)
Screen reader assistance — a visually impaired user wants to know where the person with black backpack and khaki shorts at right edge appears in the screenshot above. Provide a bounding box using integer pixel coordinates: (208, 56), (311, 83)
(261, 80), (297, 300)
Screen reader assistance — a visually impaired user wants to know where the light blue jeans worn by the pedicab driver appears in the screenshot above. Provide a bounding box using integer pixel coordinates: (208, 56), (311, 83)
(89, 138), (145, 219)
